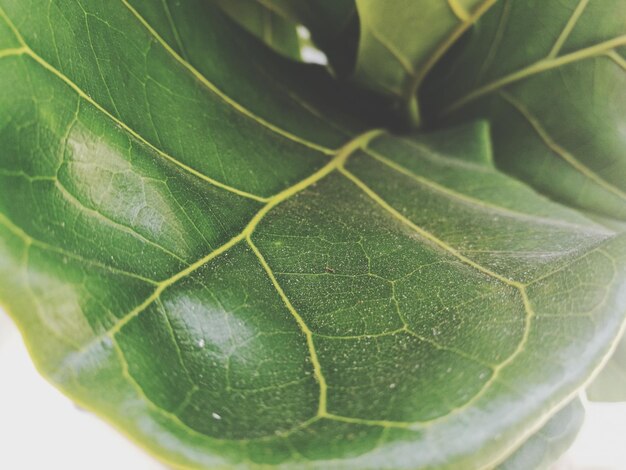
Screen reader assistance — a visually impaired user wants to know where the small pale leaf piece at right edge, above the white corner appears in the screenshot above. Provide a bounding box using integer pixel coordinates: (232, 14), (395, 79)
(587, 339), (626, 402)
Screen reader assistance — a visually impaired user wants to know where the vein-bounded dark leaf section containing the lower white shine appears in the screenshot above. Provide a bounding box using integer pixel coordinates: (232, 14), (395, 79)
(118, 245), (318, 439)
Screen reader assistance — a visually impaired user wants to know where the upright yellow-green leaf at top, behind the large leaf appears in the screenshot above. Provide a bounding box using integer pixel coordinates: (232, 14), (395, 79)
(355, 0), (495, 122)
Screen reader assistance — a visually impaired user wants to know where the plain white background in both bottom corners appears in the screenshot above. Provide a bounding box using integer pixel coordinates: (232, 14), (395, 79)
(0, 310), (626, 470)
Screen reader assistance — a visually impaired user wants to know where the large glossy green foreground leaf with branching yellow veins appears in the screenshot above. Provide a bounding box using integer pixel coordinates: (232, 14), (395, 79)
(0, 0), (626, 468)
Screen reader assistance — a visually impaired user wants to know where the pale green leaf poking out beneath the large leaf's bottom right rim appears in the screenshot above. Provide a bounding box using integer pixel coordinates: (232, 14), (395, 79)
(498, 399), (585, 470)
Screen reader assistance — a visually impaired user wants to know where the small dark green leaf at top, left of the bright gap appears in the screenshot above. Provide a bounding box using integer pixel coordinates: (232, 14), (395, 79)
(210, 0), (300, 59)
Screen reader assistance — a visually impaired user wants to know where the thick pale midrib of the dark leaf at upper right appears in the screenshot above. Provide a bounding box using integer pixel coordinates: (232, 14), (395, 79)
(440, 35), (626, 117)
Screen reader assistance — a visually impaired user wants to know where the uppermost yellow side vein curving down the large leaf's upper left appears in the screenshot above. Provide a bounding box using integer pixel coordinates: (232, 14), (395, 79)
(120, 0), (336, 155)
